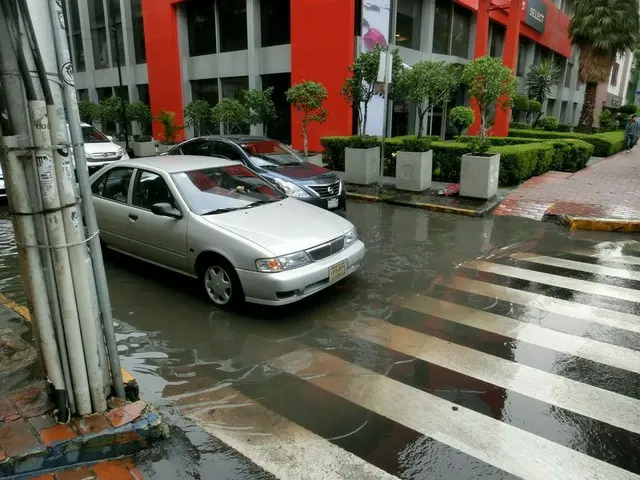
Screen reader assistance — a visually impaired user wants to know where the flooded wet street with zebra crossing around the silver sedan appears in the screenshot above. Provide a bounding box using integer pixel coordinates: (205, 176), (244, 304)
(0, 202), (640, 479)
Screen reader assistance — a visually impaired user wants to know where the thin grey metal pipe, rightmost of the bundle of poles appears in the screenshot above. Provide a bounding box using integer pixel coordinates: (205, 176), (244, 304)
(49, 0), (125, 399)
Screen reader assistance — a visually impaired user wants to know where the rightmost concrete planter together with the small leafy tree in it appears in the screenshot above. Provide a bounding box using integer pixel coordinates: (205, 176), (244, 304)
(460, 57), (517, 199)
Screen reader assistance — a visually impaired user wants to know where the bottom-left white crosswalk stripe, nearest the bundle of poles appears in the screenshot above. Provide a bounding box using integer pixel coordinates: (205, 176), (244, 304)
(182, 388), (398, 480)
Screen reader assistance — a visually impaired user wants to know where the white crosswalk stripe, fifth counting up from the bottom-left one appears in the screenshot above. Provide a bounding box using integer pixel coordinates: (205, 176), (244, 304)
(442, 277), (640, 333)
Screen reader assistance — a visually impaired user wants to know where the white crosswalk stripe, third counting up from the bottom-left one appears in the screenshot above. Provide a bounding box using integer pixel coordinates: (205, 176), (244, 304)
(332, 318), (640, 433)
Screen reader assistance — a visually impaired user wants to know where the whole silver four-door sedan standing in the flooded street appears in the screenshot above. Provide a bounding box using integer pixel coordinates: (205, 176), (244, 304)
(91, 155), (365, 307)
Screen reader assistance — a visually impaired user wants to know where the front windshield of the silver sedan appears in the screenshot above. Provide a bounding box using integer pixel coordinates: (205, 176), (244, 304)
(172, 165), (286, 215)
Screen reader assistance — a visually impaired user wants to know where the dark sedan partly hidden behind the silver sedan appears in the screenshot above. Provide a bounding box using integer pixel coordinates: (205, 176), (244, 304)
(168, 135), (347, 213)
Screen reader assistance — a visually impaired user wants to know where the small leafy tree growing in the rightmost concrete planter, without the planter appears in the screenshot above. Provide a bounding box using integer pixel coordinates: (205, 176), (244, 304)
(462, 57), (518, 149)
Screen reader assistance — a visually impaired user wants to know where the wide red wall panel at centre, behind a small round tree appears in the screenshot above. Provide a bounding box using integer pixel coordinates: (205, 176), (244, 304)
(291, 0), (355, 151)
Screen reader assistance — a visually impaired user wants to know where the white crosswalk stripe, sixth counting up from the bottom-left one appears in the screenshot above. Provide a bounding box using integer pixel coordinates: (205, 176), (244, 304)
(464, 260), (640, 302)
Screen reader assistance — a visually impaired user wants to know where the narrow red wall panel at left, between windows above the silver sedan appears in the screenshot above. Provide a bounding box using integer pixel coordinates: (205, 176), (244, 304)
(142, 0), (184, 140)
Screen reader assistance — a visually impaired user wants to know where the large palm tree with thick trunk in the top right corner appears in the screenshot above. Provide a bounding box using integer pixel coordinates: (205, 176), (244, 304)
(569, 0), (640, 127)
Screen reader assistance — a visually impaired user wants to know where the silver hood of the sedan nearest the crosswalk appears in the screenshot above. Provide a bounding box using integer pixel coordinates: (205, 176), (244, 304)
(201, 198), (353, 256)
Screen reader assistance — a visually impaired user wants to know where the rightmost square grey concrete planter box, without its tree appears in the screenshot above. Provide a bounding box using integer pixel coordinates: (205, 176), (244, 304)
(460, 154), (500, 200)
